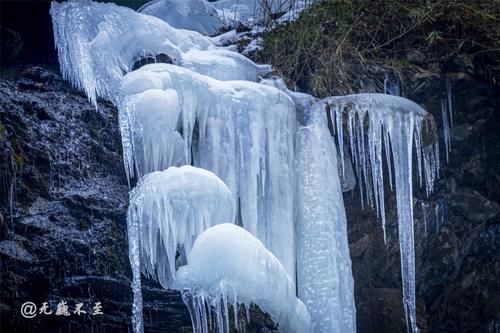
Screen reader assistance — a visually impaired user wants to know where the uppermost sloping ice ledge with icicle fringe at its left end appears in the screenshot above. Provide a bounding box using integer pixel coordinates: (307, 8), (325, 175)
(50, 0), (270, 106)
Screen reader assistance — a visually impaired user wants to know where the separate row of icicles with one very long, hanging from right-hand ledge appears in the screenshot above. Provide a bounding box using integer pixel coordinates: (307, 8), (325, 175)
(318, 94), (439, 332)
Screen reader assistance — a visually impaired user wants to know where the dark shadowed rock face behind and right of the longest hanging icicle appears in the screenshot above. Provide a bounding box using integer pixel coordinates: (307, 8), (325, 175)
(344, 68), (500, 332)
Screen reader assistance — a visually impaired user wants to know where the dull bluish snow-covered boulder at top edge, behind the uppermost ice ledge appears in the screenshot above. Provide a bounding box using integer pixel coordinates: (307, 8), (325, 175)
(138, 0), (223, 35)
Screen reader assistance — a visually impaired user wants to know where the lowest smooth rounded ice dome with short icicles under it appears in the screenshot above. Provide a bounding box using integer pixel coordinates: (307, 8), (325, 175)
(176, 224), (310, 333)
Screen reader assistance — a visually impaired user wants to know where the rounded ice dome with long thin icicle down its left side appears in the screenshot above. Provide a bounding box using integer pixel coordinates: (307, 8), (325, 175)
(127, 166), (235, 332)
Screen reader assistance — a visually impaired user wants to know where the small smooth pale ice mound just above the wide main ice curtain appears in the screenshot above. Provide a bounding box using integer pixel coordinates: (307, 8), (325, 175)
(181, 49), (271, 81)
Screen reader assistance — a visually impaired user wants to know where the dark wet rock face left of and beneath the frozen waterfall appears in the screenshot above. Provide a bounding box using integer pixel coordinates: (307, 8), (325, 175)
(0, 66), (274, 333)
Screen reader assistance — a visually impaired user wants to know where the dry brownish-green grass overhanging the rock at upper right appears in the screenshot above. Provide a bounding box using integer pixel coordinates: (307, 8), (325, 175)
(258, 0), (500, 96)
